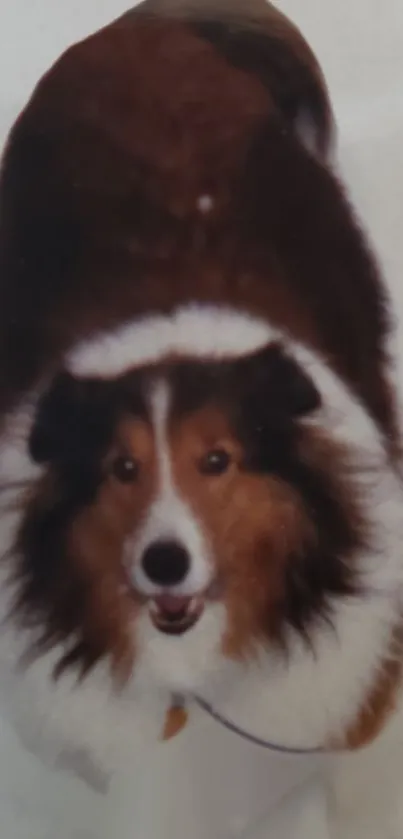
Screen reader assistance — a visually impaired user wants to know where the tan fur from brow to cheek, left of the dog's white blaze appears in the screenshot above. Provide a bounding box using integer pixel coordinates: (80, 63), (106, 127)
(68, 423), (155, 680)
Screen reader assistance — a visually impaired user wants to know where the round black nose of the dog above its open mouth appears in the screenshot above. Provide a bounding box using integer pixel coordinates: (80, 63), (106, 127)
(142, 542), (190, 586)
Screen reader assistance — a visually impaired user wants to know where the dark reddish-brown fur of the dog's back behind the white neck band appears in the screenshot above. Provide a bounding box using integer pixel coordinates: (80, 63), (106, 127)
(0, 3), (397, 450)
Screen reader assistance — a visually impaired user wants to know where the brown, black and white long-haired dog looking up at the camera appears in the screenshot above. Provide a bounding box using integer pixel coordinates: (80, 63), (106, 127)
(0, 0), (403, 839)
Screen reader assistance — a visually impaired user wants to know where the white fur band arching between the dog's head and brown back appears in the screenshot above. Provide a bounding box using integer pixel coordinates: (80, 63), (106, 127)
(66, 304), (279, 377)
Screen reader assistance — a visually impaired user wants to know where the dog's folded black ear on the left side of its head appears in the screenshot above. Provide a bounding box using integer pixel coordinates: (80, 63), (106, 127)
(29, 373), (111, 464)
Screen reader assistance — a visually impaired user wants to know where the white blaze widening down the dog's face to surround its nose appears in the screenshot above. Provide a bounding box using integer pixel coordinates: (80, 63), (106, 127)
(128, 381), (212, 596)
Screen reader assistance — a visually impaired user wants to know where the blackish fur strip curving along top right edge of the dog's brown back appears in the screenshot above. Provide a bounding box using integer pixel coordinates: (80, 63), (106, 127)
(121, 0), (334, 157)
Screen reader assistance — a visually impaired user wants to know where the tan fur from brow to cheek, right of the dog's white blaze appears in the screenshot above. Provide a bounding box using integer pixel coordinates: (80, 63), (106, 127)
(172, 409), (314, 657)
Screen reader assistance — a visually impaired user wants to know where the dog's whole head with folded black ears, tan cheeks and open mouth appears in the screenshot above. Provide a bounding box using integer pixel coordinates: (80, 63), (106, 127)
(13, 343), (362, 688)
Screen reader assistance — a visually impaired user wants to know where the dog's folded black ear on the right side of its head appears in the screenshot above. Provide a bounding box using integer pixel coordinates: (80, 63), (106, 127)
(241, 344), (321, 422)
